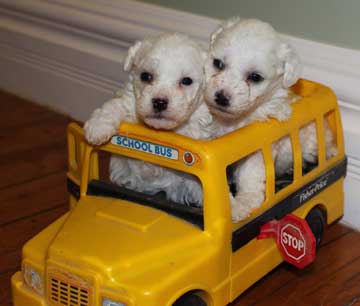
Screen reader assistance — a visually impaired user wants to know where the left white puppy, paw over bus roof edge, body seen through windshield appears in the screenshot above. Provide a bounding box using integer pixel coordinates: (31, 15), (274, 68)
(84, 34), (212, 205)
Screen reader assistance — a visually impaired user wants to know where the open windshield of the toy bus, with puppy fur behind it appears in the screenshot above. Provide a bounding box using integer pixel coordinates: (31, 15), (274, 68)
(87, 150), (203, 228)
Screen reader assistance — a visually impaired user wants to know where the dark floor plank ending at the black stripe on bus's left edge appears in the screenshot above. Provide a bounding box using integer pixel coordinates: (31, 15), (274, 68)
(0, 171), (69, 226)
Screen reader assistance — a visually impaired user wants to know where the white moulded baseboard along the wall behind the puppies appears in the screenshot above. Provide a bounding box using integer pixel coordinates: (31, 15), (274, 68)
(0, 0), (360, 229)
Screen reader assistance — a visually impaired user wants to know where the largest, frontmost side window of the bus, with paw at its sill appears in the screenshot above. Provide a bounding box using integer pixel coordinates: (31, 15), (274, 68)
(226, 150), (266, 220)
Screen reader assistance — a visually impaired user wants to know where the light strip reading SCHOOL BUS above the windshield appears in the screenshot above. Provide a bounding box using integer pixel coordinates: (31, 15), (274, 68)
(111, 135), (179, 160)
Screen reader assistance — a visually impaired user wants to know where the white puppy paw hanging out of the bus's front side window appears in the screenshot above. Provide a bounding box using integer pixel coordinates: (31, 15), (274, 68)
(230, 192), (264, 222)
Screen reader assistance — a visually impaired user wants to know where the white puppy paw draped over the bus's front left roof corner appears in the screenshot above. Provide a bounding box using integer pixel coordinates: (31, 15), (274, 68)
(84, 118), (117, 145)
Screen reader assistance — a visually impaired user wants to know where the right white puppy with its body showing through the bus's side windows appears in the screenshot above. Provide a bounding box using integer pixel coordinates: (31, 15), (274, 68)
(205, 18), (338, 221)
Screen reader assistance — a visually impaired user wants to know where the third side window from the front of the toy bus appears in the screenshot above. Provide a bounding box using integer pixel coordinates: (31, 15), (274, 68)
(299, 120), (319, 175)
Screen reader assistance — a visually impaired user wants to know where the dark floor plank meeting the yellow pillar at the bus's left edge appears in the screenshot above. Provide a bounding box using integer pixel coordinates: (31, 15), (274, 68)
(0, 141), (67, 189)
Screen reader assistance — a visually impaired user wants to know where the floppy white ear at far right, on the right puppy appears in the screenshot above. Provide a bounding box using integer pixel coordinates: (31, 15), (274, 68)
(278, 43), (301, 88)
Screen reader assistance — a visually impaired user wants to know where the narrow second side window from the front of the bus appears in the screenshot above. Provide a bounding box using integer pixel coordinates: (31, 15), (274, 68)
(272, 135), (294, 192)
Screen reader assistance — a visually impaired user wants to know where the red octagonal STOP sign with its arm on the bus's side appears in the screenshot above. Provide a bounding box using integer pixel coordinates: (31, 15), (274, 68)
(258, 214), (316, 269)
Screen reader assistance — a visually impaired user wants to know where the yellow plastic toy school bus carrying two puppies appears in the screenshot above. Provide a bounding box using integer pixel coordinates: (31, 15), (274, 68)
(12, 80), (346, 306)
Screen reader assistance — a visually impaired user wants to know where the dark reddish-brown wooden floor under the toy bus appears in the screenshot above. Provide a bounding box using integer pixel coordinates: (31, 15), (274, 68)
(0, 92), (360, 306)
